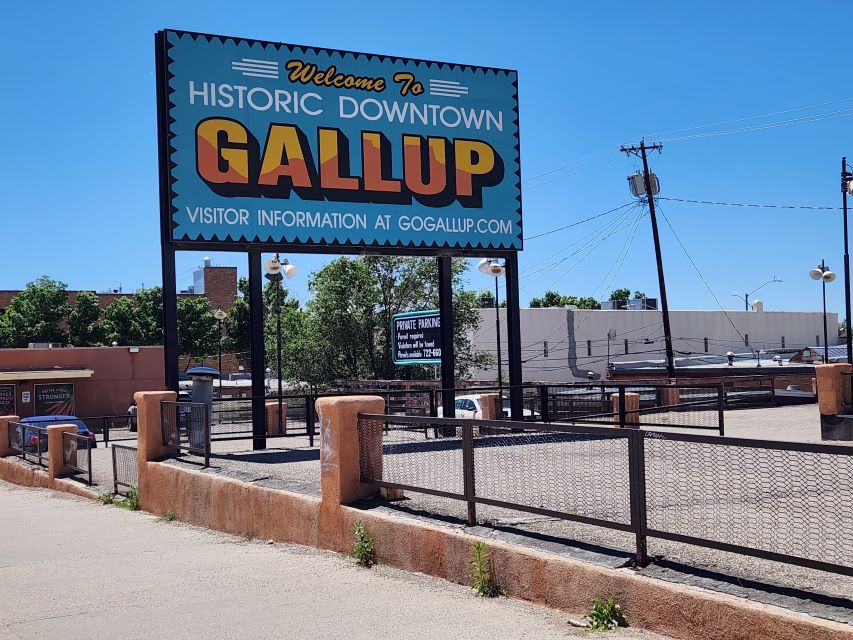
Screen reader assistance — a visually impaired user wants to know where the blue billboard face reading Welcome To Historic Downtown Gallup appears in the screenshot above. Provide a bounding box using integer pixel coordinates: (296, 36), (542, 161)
(158, 31), (522, 250)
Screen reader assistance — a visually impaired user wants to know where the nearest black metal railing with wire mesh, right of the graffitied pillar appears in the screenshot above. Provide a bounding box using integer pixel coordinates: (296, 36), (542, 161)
(358, 414), (853, 576)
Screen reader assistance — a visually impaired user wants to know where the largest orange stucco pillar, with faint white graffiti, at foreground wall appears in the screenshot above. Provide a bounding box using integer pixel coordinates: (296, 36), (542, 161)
(316, 396), (385, 505)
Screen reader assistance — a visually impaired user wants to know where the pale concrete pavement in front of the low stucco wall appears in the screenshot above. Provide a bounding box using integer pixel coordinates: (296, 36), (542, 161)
(0, 482), (662, 640)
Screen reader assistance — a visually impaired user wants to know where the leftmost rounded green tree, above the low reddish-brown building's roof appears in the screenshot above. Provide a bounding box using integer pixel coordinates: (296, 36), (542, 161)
(0, 276), (69, 347)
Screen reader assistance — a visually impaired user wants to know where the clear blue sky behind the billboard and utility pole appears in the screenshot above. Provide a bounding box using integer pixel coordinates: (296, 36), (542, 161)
(0, 1), (853, 311)
